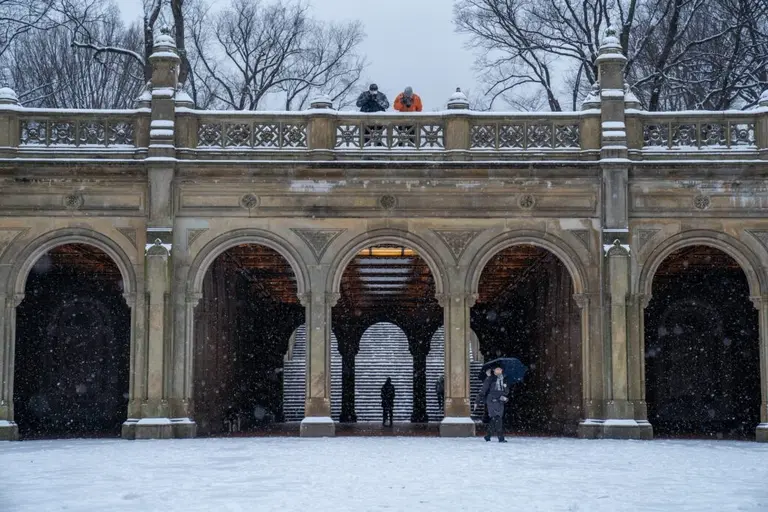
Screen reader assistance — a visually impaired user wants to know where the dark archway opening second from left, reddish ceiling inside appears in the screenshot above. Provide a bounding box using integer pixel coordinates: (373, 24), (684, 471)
(193, 244), (304, 436)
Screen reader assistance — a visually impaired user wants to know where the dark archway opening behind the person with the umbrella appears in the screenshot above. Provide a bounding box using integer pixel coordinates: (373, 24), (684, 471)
(470, 244), (582, 435)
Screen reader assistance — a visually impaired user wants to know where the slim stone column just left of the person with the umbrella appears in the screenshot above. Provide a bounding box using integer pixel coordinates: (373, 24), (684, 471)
(438, 292), (476, 437)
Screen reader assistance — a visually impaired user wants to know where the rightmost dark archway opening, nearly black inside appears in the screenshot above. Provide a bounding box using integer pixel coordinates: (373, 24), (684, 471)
(645, 245), (760, 438)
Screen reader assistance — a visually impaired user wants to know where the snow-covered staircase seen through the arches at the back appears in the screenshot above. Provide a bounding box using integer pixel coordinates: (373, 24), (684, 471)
(283, 323), (456, 422)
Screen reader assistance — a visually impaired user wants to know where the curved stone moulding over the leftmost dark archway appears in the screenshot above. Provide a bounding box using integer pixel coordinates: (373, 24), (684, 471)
(8, 228), (137, 308)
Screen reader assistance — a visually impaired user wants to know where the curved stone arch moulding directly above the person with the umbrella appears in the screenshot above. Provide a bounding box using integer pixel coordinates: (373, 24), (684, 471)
(466, 230), (588, 295)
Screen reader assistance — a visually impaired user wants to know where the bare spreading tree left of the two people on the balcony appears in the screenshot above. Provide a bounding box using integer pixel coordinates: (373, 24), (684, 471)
(188, 0), (365, 110)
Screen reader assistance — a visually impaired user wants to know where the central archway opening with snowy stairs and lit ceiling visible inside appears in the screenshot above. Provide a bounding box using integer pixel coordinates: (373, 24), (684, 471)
(332, 243), (444, 423)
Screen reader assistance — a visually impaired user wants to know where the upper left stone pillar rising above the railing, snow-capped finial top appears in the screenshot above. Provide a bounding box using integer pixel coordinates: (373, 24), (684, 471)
(147, 28), (181, 228)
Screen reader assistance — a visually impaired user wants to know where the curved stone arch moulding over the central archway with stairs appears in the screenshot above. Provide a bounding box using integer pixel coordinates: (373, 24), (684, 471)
(326, 229), (447, 297)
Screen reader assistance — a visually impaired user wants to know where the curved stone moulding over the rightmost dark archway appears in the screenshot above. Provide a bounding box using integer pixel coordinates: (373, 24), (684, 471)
(637, 230), (765, 304)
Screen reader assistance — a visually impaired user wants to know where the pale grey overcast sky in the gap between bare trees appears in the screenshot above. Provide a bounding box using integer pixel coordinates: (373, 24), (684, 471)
(117, 0), (477, 110)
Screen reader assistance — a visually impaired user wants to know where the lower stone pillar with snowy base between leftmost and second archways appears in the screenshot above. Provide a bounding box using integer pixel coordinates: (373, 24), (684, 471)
(123, 239), (173, 439)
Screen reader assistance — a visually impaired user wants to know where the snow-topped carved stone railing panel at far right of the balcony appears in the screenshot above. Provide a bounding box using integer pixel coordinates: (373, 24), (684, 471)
(627, 111), (759, 152)
